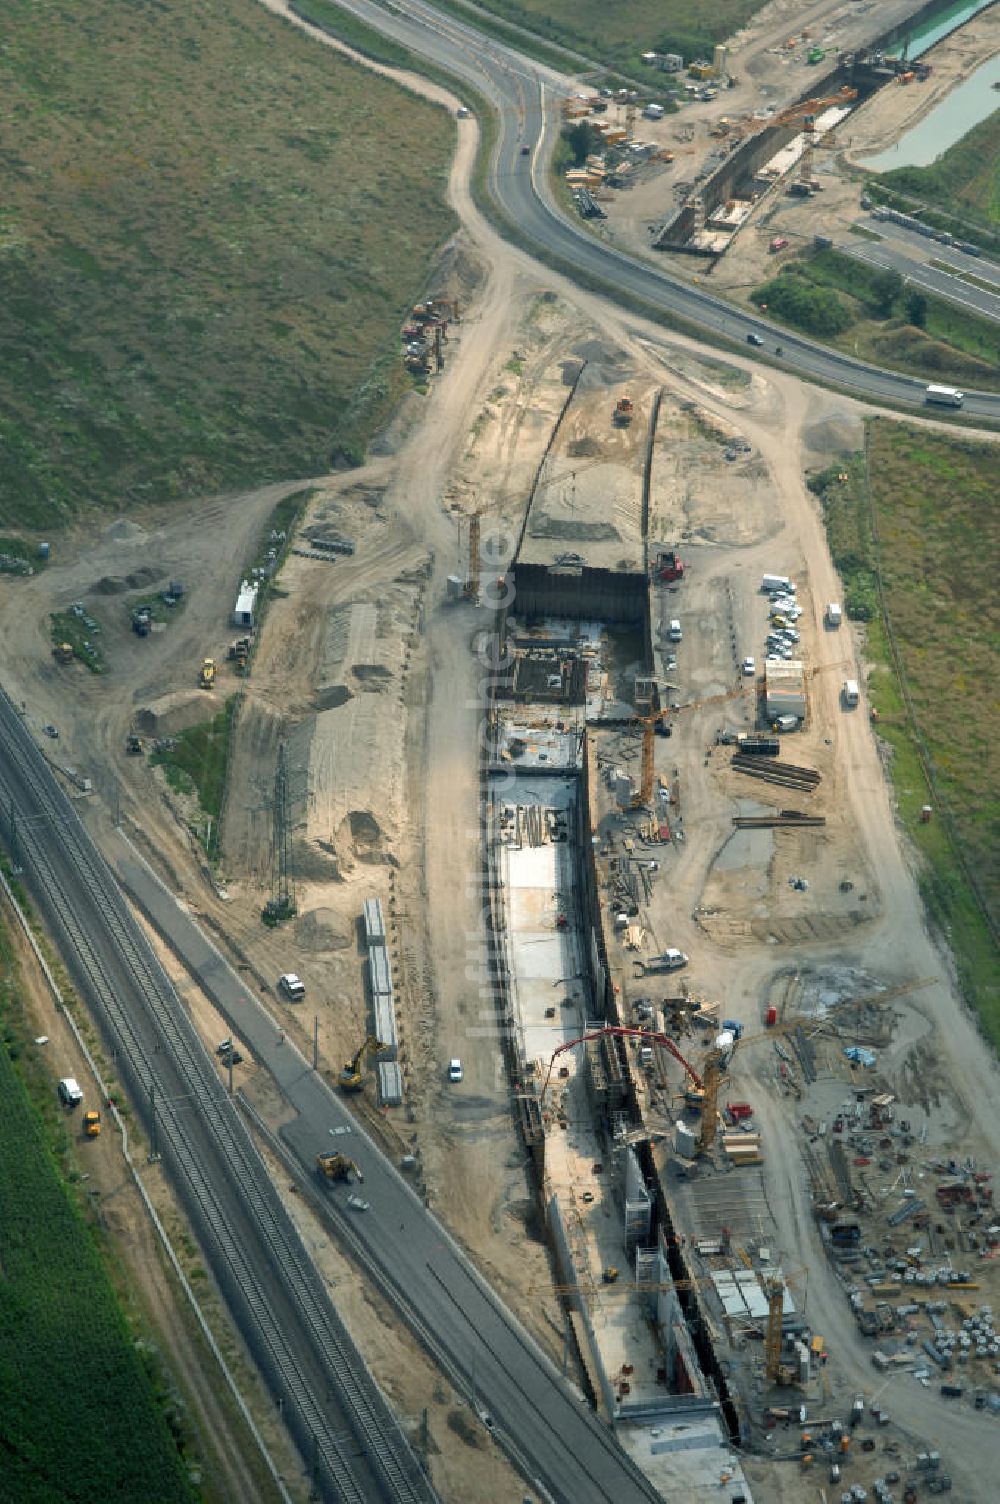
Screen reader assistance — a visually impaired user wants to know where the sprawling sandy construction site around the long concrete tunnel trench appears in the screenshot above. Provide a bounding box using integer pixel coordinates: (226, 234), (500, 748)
(0, 0), (1000, 1504)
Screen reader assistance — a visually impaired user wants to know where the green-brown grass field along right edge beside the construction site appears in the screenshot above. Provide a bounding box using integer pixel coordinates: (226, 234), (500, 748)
(812, 420), (1000, 1044)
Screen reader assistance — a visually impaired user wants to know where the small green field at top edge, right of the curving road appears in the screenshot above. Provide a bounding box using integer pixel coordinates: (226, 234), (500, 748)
(448, 0), (764, 74)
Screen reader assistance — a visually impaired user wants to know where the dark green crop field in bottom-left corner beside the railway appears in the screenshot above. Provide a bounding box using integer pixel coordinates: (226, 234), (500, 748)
(0, 928), (197, 1504)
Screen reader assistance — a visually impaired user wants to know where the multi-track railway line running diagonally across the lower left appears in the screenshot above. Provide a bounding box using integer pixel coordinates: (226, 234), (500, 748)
(0, 692), (435, 1504)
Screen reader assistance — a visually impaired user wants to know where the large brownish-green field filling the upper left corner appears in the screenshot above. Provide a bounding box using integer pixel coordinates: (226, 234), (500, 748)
(0, 0), (454, 529)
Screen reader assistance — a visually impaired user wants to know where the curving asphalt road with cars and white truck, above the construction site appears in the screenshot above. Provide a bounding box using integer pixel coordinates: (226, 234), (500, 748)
(309, 0), (1000, 421)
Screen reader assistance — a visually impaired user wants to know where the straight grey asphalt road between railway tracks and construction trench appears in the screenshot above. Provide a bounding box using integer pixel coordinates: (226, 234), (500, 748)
(111, 841), (660, 1504)
